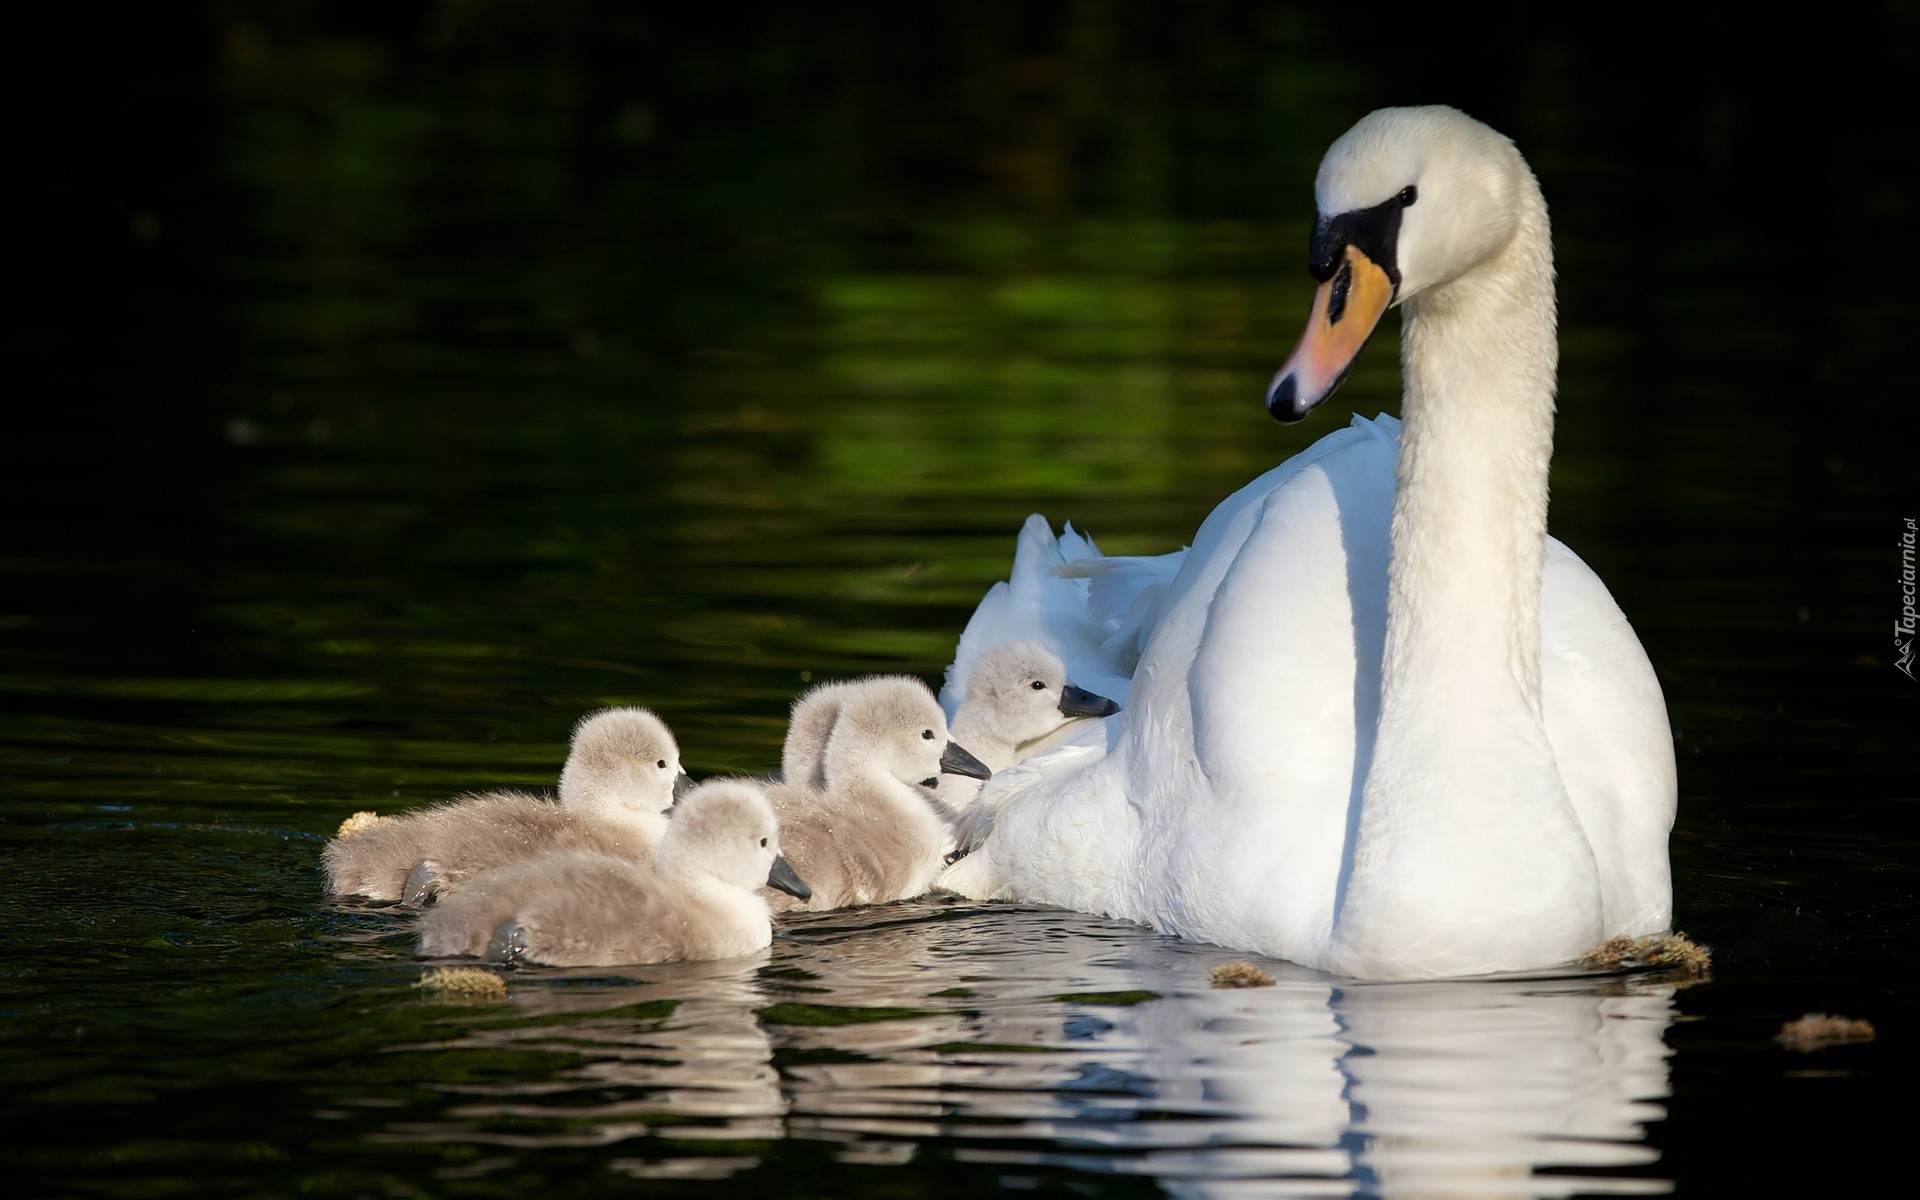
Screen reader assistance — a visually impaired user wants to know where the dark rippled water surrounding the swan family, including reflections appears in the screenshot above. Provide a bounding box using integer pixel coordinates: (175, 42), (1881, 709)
(0, 2), (1920, 1196)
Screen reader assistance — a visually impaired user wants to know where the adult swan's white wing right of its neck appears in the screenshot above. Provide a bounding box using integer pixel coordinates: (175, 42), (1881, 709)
(1540, 538), (1678, 935)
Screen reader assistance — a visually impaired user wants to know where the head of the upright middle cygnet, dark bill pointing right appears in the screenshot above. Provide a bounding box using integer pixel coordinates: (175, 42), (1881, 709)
(822, 676), (993, 787)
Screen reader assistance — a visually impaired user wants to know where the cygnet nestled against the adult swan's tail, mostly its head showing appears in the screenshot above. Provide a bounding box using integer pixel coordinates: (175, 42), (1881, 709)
(935, 641), (1119, 812)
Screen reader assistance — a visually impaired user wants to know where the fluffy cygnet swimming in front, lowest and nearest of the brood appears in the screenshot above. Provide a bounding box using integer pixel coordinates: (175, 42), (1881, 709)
(420, 780), (808, 966)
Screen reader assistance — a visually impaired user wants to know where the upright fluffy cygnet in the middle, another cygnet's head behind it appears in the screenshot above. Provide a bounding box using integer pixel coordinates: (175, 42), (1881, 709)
(770, 676), (991, 912)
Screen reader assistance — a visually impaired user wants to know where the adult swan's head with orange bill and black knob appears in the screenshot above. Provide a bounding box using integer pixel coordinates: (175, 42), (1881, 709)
(1267, 106), (1532, 422)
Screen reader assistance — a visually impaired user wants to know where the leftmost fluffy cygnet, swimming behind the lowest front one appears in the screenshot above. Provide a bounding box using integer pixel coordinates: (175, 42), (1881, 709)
(323, 708), (691, 904)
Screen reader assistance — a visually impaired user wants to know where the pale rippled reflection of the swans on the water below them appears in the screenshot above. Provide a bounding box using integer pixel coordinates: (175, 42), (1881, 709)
(386, 900), (1674, 1196)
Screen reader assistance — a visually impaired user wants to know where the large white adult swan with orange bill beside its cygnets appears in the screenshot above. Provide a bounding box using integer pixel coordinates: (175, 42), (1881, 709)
(945, 108), (1676, 979)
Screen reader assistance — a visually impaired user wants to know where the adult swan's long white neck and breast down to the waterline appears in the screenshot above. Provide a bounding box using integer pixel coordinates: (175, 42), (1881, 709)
(1331, 166), (1601, 977)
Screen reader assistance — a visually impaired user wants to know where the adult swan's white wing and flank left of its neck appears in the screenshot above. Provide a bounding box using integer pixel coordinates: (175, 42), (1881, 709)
(967, 420), (1394, 962)
